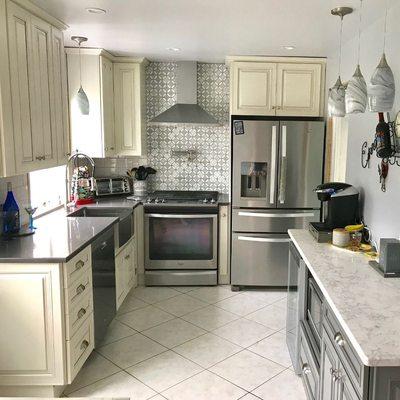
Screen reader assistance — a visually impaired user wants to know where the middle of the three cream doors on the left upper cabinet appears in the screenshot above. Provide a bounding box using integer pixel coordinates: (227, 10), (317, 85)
(31, 16), (57, 168)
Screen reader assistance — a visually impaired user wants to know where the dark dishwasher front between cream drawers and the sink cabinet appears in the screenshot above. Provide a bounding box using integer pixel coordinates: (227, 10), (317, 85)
(92, 225), (117, 346)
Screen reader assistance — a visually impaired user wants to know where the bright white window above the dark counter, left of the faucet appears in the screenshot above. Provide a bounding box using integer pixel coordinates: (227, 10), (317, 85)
(29, 166), (66, 217)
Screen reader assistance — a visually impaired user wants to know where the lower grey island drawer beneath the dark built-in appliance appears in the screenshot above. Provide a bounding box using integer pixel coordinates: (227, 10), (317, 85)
(299, 323), (319, 400)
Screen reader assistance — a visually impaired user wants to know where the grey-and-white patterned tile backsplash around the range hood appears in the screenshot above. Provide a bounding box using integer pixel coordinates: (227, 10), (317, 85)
(146, 62), (231, 193)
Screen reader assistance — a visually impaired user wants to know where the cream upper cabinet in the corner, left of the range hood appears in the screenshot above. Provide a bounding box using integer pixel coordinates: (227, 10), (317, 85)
(66, 48), (145, 157)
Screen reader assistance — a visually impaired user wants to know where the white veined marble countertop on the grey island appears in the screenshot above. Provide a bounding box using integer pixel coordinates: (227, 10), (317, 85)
(289, 229), (400, 367)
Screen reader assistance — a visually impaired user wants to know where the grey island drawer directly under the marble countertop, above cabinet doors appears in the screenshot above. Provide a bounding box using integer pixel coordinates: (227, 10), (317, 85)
(324, 304), (367, 392)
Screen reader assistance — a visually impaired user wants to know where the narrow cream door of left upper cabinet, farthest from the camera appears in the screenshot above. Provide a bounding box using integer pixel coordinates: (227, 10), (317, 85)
(51, 27), (70, 165)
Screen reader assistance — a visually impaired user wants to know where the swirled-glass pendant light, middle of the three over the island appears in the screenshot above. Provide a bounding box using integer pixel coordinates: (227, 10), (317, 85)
(345, 0), (368, 114)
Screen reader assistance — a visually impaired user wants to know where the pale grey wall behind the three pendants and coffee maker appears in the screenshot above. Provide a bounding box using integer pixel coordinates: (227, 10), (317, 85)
(327, 2), (400, 245)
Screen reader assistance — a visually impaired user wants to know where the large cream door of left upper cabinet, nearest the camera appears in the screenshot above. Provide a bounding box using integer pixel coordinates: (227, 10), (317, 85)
(7, 1), (42, 173)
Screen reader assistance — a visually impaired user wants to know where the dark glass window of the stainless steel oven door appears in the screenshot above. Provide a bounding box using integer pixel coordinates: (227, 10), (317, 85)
(149, 217), (213, 260)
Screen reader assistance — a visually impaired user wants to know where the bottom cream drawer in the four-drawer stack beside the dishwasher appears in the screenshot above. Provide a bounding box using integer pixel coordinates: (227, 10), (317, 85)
(67, 313), (94, 383)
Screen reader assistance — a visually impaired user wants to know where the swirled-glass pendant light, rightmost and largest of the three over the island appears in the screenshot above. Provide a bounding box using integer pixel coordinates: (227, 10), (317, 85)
(368, 0), (395, 112)
